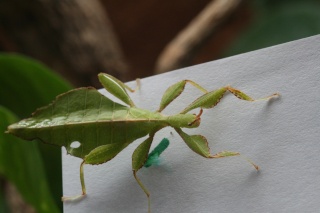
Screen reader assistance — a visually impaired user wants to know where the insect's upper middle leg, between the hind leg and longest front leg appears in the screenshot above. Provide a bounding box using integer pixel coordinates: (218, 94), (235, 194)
(157, 80), (208, 112)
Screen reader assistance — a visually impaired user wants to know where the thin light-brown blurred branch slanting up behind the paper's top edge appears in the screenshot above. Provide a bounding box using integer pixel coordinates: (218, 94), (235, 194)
(155, 0), (242, 74)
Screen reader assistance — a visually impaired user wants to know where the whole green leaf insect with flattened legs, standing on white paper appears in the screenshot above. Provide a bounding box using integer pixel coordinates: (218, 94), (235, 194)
(7, 73), (278, 212)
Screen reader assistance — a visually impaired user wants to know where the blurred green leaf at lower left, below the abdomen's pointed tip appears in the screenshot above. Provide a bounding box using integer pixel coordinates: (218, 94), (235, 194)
(0, 107), (59, 213)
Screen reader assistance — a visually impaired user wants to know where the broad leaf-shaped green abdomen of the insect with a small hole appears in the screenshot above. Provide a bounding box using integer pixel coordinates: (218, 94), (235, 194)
(8, 88), (168, 158)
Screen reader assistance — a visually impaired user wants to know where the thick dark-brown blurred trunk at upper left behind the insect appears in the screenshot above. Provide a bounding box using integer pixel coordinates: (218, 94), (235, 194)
(0, 0), (127, 87)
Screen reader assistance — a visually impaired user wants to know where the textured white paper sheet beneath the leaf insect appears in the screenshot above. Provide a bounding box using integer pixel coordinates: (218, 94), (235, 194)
(63, 36), (320, 213)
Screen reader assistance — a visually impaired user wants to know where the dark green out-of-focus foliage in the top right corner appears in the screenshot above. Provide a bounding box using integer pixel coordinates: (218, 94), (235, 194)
(225, 0), (320, 56)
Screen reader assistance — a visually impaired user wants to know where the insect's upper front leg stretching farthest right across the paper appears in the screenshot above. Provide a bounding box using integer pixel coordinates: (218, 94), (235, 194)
(180, 86), (279, 114)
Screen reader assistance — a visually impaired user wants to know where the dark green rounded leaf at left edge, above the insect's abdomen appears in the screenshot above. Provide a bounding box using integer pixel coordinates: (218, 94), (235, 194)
(0, 54), (72, 118)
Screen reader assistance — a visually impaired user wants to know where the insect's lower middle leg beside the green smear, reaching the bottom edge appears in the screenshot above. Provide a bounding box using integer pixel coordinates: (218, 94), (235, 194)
(132, 133), (154, 213)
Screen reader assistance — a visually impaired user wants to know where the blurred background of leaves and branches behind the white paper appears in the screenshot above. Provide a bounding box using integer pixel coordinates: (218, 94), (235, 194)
(0, 0), (320, 213)
